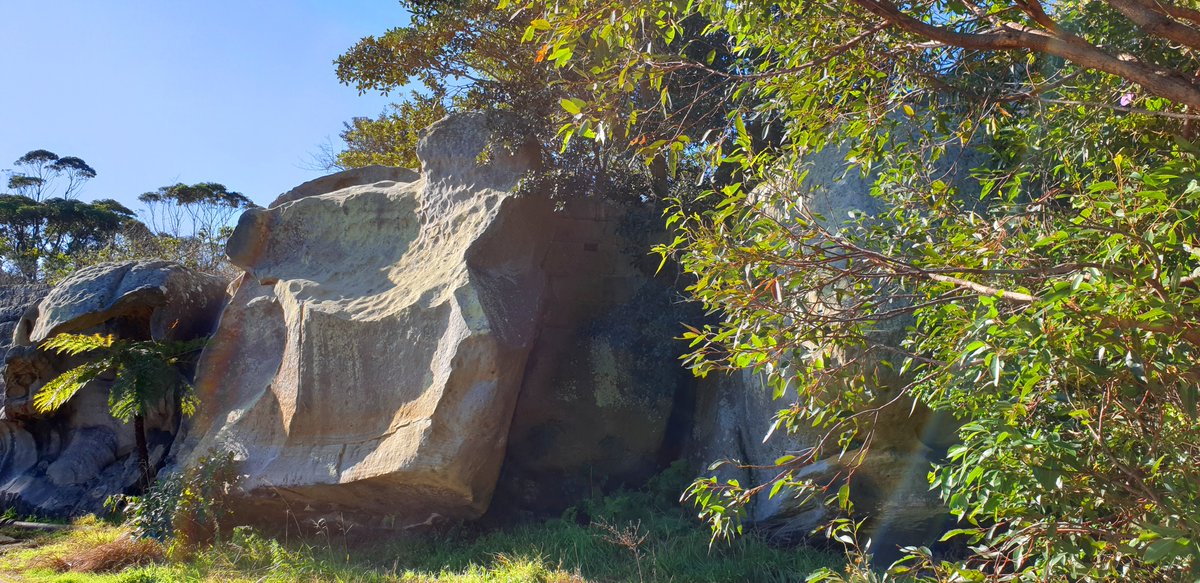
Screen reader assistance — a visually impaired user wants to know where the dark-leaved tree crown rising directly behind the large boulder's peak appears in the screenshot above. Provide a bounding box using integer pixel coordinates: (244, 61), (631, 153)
(336, 0), (744, 203)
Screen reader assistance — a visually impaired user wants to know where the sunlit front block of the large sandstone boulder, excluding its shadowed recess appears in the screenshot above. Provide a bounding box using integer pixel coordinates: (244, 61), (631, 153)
(183, 111), (552, 519)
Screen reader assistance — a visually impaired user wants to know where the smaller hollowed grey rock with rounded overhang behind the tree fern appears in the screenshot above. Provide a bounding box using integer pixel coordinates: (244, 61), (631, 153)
(0, 262), (226, 516)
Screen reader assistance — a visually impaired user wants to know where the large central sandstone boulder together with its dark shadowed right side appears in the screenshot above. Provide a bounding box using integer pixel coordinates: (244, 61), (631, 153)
(178, 115), (686, 525)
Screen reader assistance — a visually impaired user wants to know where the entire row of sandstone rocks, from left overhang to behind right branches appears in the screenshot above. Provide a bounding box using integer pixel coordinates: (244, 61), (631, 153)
(0, 114), (944, 556)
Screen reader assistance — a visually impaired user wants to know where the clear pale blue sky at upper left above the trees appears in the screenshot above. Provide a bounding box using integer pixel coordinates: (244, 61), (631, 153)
(0, 0), (407, 209)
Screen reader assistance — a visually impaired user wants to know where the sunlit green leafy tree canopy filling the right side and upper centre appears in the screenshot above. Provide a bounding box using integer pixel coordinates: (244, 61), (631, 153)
(338, 0), (1200, 581)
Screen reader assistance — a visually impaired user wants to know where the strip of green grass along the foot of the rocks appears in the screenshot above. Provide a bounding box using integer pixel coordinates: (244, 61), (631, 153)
(0, 470), (844, 583)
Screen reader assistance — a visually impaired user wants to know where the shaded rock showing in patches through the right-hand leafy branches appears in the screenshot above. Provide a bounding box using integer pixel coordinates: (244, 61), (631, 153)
(688, 140), (960, 565)
